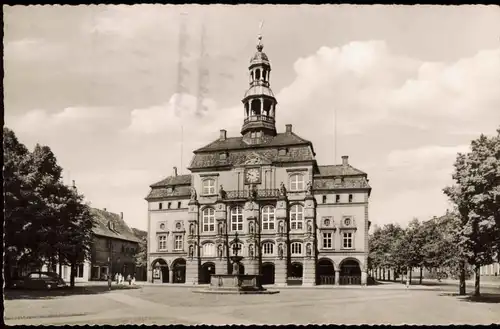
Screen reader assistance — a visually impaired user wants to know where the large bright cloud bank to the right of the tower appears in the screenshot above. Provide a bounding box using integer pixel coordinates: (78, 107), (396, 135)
(277, 41), (500, 134)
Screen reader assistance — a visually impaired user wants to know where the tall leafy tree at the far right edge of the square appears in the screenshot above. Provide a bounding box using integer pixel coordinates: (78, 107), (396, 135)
(444, 129), (500, 295)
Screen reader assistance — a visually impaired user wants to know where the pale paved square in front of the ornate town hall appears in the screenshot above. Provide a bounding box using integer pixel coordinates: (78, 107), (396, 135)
(5, 283), (500, 325)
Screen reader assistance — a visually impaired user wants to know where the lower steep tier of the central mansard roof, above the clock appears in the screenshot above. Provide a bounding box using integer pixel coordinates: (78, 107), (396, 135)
(190, 145), (314, 169)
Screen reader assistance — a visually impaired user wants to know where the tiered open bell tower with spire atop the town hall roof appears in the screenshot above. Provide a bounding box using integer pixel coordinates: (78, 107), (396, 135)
(241, 35), (277, 144)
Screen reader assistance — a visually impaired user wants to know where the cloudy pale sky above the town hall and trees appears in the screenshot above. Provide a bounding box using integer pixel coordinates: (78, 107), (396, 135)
(3, 5), (500, 229)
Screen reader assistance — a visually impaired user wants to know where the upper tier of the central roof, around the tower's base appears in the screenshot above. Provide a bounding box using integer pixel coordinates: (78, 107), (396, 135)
(194, 132), (312, 153)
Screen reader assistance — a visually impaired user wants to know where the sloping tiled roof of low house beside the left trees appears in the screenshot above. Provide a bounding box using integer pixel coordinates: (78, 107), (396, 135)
(90, 208), (139, 242)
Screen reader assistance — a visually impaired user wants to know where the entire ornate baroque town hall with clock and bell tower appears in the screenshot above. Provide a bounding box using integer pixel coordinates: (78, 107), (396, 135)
(146, 37), (371, 285)
